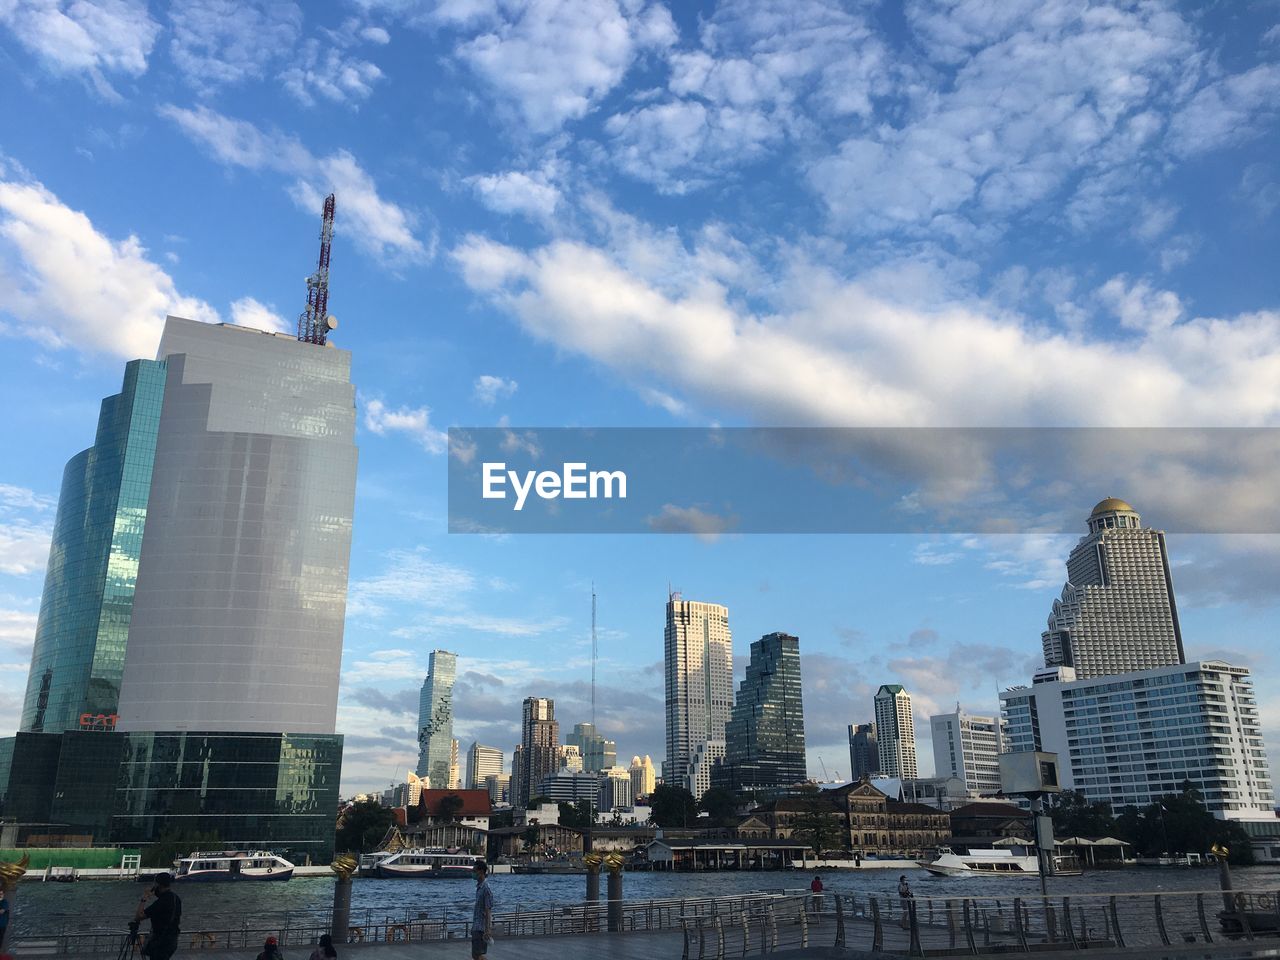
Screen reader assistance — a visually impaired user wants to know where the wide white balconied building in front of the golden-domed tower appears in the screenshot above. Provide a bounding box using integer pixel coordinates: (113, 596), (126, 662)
(1000, 660), (1275, 824)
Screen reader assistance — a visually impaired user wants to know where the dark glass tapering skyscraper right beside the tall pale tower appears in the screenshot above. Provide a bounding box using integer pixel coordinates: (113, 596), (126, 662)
(712, 634), (806, 796)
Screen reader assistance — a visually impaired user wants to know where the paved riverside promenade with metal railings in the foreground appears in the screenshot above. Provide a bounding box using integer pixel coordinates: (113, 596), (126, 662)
(12, 890), (1280, 960)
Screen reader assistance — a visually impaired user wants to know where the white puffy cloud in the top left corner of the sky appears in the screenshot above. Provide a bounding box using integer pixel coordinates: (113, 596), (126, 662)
(0, 0), (160, 97)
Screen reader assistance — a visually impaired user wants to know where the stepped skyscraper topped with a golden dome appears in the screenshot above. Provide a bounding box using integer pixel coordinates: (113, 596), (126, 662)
(1041, 497), (1187, 680)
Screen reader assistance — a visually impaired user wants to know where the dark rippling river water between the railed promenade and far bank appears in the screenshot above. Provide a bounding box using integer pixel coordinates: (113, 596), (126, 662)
(13, 867), (1280, 936)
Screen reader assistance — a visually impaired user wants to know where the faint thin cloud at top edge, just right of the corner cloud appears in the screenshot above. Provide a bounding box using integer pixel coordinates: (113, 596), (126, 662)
(169, 0), (302, 92)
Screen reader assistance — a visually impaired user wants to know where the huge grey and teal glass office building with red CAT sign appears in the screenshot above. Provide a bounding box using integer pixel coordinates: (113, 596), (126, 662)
(0, 317), (356, 860)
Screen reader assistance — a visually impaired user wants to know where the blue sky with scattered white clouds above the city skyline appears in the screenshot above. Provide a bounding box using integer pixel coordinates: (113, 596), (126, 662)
(0, 0), (1280, 792)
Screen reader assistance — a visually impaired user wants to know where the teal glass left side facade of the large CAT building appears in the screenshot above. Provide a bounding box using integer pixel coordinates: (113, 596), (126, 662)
(20, 360), (165, 733)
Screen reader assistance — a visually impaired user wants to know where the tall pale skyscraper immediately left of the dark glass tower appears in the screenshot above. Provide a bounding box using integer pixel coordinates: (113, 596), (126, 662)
(662, 594), (733, 797)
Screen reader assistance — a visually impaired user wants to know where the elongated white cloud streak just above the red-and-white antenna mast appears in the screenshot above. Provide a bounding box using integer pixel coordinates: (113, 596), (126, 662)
(160, 105), (424, 262)
